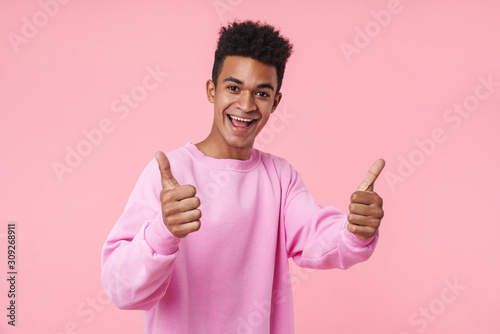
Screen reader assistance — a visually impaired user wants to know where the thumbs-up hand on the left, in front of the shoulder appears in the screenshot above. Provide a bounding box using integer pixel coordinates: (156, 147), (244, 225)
(155, 151), (201, 238)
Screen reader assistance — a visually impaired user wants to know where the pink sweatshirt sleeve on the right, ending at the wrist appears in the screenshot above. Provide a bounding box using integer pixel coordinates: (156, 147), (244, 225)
(282, 161), (379, 269)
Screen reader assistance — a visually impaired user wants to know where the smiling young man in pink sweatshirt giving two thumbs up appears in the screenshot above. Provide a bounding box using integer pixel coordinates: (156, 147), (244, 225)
(102, 21), (384, 334)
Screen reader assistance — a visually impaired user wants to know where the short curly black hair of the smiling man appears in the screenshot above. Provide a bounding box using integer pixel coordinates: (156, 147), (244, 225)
(212, 20), (293, 94)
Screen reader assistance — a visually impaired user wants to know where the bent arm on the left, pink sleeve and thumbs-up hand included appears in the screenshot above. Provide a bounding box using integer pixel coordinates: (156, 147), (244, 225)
(101, 152), (201, 310)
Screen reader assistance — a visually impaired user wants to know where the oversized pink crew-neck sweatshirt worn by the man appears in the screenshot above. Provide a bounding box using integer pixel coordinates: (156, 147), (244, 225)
(101, 142), (378, 334)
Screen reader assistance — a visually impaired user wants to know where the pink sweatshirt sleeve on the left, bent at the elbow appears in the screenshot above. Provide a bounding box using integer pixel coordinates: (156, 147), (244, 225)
(101, 159), (180, 310)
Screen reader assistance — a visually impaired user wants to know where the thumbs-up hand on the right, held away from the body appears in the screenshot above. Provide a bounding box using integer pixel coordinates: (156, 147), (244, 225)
(347, 159), (385, 240)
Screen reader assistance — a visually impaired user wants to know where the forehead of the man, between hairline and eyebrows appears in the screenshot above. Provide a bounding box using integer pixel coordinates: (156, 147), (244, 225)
(218, 56), (278, 88)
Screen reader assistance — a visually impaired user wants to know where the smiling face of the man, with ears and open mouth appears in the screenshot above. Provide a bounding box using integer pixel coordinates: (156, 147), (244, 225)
(207, 56), (281, 155)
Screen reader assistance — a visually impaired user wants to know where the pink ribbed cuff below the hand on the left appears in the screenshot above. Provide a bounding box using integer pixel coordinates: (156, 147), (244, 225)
(144, 212), (181, 255)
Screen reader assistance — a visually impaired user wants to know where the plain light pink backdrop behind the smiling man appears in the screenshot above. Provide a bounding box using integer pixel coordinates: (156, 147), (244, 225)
(0, 0), (500, 334)
